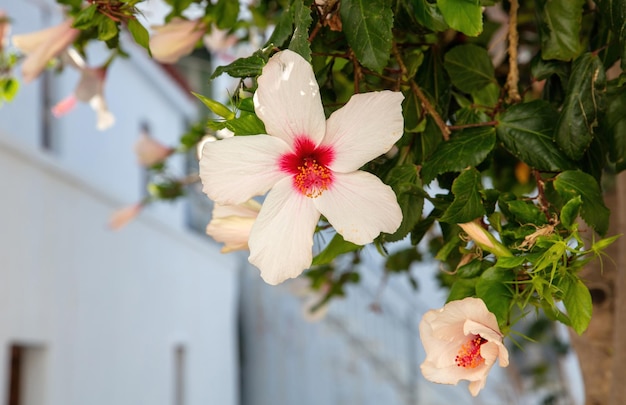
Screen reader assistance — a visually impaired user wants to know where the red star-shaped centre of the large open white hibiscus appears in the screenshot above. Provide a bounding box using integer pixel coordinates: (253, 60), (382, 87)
(278, 136), (335, 198)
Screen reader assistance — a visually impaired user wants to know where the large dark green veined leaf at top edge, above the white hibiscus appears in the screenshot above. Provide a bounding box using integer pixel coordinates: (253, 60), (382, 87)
(340, 0), (393, 72)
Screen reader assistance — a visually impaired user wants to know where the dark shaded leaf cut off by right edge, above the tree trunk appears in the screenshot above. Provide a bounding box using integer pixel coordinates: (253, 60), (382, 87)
(602, 82), (626, 172)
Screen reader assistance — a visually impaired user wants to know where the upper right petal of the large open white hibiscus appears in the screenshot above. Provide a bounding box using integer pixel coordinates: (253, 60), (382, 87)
(323, 91), (404, 173)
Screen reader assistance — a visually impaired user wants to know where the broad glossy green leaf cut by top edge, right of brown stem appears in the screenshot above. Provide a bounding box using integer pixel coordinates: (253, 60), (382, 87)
(537, 0), (585, 61)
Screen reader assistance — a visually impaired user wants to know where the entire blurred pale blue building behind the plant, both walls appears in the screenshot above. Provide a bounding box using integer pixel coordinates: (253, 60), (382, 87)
(0, 0), (580, 405)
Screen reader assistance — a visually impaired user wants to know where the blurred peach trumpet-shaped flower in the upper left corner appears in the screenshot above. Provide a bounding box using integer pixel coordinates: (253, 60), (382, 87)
(12, 19), (80, 83)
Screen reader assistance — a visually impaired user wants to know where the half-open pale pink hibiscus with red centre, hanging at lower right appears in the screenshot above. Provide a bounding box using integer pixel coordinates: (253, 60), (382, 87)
(419, 297), (509, 396)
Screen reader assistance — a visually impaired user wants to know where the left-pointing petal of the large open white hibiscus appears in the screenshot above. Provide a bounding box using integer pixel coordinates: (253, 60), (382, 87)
(200, 135), (289, 205)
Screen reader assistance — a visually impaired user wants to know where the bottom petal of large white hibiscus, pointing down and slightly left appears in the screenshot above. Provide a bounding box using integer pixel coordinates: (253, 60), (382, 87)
(248, 178), (320, 285)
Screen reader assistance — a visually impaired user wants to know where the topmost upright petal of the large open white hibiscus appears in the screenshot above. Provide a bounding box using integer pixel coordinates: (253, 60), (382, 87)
(254, 50), (326, 145)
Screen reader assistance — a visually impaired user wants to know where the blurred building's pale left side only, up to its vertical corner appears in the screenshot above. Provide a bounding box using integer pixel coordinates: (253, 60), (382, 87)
(0, 0), (241, 405)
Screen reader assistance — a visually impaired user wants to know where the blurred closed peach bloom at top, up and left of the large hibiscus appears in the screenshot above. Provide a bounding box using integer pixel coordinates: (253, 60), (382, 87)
(150, 18), (206, 63)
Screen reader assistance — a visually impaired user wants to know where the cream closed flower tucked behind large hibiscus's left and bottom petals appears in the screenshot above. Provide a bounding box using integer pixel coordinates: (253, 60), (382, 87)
(206, 200), (261, 253)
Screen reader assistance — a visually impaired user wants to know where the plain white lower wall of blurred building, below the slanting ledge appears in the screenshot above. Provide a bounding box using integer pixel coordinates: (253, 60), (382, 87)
(0, 138), (239, 405)
